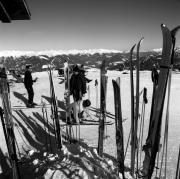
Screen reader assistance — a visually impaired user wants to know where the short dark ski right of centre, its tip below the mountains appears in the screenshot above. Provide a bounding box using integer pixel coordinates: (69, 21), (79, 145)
(112, 78), (125, 179)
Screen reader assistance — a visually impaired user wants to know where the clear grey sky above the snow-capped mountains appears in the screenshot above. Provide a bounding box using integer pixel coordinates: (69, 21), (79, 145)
(0, 0), (180, 51)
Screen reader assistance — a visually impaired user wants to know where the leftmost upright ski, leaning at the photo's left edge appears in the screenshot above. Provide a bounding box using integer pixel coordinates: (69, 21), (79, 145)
(0, 68), (21, 179)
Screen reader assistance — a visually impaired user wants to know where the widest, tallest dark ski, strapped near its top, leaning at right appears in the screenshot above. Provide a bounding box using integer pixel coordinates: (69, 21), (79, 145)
(142, 24), (172, 179)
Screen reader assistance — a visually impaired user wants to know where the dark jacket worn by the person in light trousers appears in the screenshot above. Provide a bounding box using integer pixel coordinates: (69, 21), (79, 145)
(70, 73), (86, 101)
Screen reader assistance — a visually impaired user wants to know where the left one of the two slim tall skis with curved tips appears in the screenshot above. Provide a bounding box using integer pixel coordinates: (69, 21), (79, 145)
(129, 45), (136, 173)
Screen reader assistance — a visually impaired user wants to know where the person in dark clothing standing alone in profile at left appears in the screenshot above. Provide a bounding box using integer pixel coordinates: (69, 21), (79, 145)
(24, 64), (37, 107)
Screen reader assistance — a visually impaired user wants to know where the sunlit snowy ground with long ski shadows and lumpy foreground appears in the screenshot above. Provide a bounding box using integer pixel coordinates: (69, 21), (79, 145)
(0, 69), (180, 179)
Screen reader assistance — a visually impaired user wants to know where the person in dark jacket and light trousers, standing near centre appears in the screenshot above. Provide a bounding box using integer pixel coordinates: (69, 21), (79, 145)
(70, 65), (86, 122)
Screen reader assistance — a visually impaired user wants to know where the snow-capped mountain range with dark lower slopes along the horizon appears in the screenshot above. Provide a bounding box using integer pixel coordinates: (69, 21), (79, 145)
(0, 48), (180, 71)
